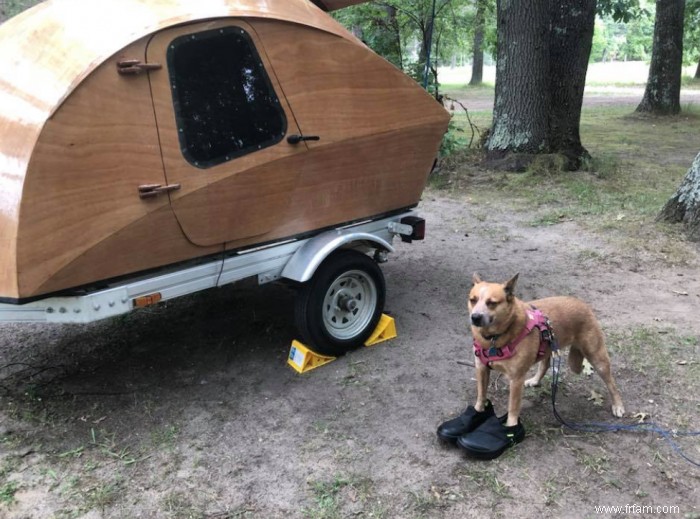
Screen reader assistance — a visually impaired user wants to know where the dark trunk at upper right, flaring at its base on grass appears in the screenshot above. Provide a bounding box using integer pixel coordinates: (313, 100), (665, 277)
(637, 0), (685, 115)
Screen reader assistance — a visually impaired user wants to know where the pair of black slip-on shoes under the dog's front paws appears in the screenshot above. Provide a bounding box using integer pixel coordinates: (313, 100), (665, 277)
(437, 400), (525, 460)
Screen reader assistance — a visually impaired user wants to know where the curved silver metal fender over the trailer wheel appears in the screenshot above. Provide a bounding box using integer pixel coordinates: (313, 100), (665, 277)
(282, 230), (394, 283)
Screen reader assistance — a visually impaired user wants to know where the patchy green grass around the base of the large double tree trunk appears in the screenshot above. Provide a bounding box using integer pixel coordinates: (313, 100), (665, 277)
(429, 106), (700, 265)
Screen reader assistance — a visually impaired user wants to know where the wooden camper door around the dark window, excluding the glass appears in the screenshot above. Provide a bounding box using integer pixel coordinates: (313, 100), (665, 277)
(148, 19), (306, 246)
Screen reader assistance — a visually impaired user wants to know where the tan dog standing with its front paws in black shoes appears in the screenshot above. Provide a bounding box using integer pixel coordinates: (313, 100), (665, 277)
(468, 274), (625, 426)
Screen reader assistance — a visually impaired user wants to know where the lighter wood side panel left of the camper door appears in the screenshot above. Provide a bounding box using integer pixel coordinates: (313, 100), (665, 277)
(17, 39), (184, 294)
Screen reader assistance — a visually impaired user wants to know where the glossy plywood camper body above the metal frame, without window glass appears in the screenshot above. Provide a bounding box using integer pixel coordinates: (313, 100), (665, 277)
(0, 0), (448, 302)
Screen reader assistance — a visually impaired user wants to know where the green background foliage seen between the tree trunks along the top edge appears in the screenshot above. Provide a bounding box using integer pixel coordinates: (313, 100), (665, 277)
(335, 0), (700, 72)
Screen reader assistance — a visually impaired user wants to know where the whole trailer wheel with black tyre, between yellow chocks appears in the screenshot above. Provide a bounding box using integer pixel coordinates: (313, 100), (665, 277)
(295, 250), (386, 356)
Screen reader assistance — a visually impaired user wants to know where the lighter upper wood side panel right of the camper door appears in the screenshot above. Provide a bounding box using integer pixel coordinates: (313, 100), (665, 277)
(253, 20), (449, 147)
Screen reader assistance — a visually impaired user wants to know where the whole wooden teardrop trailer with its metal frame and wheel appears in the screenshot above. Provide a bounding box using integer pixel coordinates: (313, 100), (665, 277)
(0, 0), (449, 355)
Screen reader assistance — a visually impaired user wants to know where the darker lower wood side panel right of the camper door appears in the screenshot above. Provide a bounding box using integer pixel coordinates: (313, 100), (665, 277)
(226, 123), (444, 249)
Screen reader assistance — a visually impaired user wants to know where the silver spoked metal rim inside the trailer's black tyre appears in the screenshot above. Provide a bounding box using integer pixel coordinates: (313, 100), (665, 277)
(323, 270), (377, 340)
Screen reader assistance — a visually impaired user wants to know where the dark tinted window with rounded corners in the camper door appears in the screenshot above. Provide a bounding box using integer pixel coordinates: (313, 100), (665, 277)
(168, 27), (287, 168)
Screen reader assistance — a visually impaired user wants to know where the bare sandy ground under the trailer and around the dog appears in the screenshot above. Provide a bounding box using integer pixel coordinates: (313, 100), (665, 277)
(0, 185), (700, 518)
